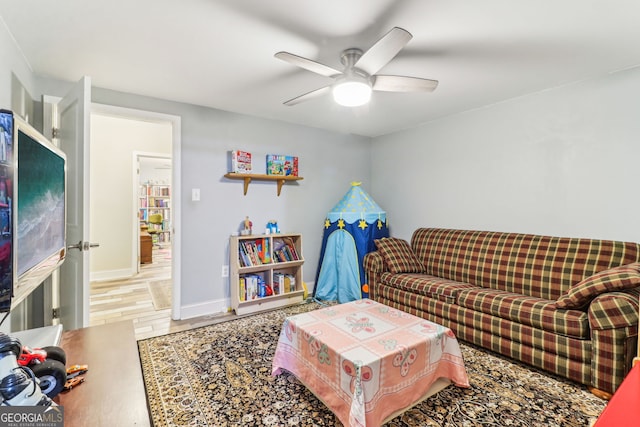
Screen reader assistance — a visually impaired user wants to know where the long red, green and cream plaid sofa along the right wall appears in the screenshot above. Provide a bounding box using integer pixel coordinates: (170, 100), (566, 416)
(364, 228), (640, 393)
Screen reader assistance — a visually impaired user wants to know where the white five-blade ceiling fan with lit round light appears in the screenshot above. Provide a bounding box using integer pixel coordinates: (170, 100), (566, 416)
(275, 27), (438, 107)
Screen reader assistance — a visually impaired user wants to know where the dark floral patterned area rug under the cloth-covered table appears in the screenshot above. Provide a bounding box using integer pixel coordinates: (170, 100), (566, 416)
(138, 303), (605, 427)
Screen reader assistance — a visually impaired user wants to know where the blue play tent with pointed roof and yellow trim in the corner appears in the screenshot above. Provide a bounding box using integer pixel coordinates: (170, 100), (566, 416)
(314, 182), (389, 303)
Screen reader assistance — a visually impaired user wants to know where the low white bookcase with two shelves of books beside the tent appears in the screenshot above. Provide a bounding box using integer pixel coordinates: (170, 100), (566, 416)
(229, 234), (304, 314)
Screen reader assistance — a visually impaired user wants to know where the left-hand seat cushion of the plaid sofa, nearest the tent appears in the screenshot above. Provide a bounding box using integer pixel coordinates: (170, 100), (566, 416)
(380, 272), (475, 304)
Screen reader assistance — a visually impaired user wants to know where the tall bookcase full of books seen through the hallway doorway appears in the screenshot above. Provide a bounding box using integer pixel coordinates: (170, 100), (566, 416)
(138, 184), (171, 246)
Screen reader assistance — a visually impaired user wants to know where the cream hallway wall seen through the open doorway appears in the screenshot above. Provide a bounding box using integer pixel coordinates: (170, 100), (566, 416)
(90, 113), (172, 280)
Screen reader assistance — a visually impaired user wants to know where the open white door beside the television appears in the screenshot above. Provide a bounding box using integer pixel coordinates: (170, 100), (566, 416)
(57, 77), (91, 330)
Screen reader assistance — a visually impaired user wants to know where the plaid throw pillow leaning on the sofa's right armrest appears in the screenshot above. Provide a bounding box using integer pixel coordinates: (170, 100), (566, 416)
(556, 262), (640, 308)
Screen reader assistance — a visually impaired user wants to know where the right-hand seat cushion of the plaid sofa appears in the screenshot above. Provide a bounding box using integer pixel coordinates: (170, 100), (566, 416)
(458, 288), (590, 339)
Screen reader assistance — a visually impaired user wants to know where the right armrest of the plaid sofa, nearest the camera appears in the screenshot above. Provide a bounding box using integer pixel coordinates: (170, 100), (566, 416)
(588, 288), (640, 393)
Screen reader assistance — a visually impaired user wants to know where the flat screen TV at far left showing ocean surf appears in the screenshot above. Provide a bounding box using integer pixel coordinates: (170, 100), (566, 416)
(0, 110), (67, 311)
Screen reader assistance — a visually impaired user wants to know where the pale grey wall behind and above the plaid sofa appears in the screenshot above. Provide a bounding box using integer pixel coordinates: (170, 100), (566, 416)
(372, 68), (640, 242)
